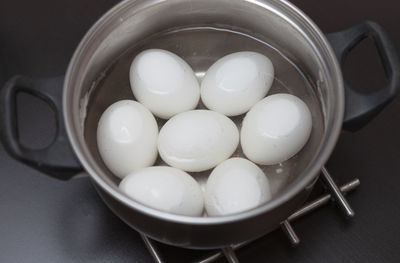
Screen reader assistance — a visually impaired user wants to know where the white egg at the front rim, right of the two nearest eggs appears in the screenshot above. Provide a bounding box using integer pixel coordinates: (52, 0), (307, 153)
(204, 158), (271, 216)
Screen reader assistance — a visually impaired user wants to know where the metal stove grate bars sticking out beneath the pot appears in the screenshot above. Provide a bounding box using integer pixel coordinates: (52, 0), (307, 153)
(141, 167), (360, 263)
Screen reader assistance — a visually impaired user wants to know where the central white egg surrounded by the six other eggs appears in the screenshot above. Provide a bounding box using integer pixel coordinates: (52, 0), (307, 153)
(158, 110), (239, 172)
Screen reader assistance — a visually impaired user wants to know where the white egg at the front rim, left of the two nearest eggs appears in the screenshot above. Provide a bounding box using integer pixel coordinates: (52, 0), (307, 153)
(119, 166), (204, 216)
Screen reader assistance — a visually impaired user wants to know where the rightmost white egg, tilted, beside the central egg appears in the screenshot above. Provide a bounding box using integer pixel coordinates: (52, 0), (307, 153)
(240, 94), (312, 165)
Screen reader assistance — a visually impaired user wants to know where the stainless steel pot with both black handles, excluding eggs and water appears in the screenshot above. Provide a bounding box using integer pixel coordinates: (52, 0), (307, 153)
(0, 0), (400, 248)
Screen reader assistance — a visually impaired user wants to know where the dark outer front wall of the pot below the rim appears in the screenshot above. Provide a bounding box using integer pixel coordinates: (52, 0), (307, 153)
(95, 185), (309, 249)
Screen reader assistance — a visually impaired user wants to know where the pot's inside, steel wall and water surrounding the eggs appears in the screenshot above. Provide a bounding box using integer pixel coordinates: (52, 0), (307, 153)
(66, 0), (341, 219)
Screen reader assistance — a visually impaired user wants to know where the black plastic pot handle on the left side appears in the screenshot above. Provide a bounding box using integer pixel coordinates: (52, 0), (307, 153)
(0, 76), (82, 180)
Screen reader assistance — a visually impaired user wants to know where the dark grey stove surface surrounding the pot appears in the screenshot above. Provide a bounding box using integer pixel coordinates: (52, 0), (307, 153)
(0, 0), (400, 263)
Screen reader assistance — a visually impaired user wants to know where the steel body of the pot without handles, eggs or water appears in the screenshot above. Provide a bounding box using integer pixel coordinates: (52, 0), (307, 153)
(64, 0), (344, 248)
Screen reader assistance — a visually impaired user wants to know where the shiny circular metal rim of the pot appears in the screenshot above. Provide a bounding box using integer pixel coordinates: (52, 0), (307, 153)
(63, 0), (344, 225)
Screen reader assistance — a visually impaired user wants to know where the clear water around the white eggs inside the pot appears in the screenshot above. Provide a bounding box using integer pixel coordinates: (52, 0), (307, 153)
(84, 27), (324, 200)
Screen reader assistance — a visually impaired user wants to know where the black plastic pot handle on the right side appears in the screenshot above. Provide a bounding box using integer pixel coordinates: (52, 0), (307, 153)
(327, 21), (400, 131)
